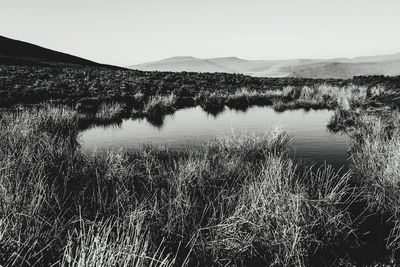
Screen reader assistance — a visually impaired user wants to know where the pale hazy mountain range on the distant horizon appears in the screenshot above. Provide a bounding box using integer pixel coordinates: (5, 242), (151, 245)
(128, 53), (400, 79)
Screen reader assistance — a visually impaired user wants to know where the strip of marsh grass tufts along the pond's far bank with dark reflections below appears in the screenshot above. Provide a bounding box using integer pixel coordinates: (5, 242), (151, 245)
(71, 84), (372, 129)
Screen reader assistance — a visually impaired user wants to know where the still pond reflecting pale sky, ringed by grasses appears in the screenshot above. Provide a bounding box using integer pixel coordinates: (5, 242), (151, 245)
(80, 107), (349, 171)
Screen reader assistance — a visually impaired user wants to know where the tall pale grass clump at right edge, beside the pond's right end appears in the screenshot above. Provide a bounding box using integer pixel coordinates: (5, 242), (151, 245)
(351, 115), (400, 211)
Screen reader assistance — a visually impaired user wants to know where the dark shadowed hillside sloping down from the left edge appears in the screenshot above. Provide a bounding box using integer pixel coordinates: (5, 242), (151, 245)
(0, 36), (118, 68)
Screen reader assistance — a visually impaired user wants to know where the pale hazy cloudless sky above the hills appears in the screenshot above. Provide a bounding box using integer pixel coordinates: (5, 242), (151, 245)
(0, 0), (400, 66)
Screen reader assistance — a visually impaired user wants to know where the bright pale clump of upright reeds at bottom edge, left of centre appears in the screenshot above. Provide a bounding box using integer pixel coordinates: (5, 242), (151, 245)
(61, 208), (174, 267)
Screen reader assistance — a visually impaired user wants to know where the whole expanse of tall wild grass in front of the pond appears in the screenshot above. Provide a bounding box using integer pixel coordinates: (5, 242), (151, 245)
(0, 105), (400, 266)
